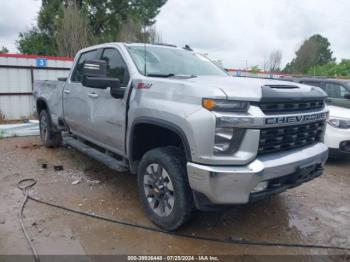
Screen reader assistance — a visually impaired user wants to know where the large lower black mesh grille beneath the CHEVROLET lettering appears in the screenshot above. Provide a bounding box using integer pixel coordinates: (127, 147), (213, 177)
(258, 121), (325, 155)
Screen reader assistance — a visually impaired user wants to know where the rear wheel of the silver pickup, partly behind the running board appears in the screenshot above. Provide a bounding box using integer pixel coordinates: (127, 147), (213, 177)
(39, 110), (62, 147)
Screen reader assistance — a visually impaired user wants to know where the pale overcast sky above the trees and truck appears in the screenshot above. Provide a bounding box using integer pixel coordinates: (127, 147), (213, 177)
(0, 0), (350, 68)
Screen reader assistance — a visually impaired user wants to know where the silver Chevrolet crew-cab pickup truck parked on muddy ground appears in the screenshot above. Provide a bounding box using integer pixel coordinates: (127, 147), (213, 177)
(34, 43), (328, 230)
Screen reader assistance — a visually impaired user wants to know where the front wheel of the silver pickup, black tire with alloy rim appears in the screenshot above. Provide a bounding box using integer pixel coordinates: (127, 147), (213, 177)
(137, 147), (194, 231)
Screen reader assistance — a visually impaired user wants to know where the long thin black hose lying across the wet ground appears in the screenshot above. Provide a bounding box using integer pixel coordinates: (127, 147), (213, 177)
(17, 179), (350, 261)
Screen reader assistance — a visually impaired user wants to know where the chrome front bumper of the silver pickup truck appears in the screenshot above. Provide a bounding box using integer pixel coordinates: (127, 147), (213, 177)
(187, 143), (328, 205)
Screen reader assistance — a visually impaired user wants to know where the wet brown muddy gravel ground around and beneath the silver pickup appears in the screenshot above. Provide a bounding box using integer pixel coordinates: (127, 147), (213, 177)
(0, 137), (350, 261)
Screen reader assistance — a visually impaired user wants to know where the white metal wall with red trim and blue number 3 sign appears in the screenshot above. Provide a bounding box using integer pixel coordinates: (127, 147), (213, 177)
(0, 54), (73, 120)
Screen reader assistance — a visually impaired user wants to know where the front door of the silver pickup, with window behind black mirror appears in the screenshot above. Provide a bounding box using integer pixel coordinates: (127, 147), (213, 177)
(86, 48), (130, 155)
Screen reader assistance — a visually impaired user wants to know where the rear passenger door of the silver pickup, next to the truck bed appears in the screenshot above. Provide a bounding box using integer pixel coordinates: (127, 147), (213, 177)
(63, 49), (99, 138)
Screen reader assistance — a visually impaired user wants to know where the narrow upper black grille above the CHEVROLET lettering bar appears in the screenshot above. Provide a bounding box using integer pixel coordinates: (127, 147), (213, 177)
(260, 100), (325, 114)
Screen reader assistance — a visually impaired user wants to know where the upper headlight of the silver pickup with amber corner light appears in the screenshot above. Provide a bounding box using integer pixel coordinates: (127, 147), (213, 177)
(202, 98), (249, 112)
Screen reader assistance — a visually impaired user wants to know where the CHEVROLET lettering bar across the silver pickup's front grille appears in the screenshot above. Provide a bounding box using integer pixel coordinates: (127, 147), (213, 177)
(265, 113), (328, 125)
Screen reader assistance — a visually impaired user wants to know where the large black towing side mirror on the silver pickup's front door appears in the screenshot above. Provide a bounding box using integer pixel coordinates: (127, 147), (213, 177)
(82, 60), (121, 89)
